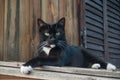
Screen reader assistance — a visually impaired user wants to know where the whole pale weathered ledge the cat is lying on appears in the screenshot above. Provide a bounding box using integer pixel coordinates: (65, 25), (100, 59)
(0, 61), (120, 80)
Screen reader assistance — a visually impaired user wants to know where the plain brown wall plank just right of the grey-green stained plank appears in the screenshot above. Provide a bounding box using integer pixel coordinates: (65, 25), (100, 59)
(19, 0), (31, 61)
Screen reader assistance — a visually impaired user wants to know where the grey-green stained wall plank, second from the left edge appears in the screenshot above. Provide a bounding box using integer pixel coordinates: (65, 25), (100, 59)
(7, 0), (19, 61)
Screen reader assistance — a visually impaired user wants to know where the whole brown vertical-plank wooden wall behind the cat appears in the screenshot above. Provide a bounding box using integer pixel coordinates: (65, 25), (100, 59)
(0, 0), (79, 61)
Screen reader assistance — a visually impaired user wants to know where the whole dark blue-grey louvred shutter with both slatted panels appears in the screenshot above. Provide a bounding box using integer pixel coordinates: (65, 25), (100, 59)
(84, 0), (120, 66)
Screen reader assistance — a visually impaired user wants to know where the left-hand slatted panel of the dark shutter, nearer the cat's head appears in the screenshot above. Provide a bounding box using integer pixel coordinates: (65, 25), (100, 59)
(85, 0), (104, 57)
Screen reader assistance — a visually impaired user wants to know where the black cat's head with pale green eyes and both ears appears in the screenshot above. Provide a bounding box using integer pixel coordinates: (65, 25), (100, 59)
(37, 17), (66, 48)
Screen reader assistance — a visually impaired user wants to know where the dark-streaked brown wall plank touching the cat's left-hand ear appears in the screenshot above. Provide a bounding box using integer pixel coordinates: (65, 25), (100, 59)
(29, 0), (42, 58)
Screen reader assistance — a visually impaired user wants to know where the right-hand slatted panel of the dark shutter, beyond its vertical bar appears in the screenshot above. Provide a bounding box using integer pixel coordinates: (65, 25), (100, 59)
(107, 0), (120, 66)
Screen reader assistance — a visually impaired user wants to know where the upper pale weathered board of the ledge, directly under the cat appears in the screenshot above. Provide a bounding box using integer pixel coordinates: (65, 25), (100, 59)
(0, 61), (120, 79)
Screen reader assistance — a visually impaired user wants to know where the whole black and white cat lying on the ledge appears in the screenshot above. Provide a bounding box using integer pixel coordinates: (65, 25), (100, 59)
(20, 18), (116, 74)
